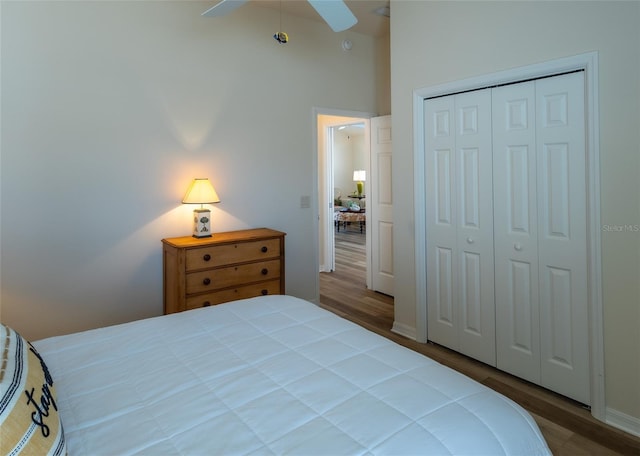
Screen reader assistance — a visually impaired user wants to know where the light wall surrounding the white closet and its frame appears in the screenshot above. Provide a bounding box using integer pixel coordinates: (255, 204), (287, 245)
(391, 0), (640, 429)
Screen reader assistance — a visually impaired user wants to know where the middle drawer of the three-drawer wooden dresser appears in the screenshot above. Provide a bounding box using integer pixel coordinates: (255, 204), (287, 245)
(187, 259), (280, 294)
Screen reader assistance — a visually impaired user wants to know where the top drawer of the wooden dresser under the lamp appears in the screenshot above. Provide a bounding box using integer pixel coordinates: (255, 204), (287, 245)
(187, 239), (280, 271)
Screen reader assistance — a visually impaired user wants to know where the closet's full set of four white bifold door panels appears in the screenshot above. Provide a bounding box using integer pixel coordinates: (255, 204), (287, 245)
(424, 71), (590, 404)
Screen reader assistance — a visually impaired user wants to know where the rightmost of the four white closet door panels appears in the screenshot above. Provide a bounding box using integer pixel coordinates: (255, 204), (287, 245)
(536, 72), (590, 404)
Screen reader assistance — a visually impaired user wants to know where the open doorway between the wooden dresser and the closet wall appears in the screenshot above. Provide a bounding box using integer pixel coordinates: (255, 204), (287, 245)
(314, 109), (394, 329)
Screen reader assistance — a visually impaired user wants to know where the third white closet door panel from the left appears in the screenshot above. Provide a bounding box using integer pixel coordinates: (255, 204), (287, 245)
(492, 82), (540, 383)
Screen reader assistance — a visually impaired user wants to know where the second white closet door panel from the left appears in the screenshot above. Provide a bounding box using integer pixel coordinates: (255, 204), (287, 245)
(455, 89), (496, 365)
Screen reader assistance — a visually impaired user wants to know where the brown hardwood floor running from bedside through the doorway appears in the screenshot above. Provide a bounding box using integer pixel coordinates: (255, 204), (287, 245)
(320, 232), (640, 456)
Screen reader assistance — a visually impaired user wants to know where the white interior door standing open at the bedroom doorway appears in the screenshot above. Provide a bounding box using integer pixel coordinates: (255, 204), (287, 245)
(367, 116), (394, 296)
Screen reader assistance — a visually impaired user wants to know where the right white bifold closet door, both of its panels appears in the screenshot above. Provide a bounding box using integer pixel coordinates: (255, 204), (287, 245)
(493, 72), (590, 404)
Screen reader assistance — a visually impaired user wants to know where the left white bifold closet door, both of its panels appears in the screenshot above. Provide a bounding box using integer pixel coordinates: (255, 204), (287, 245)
(425, 89), (496, 365)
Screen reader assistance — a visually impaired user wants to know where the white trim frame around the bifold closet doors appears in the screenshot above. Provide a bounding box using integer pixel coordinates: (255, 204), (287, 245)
(413, 52), (606, 421)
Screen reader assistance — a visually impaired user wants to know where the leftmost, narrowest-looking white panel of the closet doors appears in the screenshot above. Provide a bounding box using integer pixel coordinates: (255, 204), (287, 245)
(424, 97), (460, 350)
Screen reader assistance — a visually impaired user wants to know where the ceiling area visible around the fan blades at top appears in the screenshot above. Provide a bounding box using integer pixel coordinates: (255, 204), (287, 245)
(248, 0), (389, 36)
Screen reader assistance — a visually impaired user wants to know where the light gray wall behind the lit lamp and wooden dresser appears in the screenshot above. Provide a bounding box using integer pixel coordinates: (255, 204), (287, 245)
(0, 1), (380, 339)
